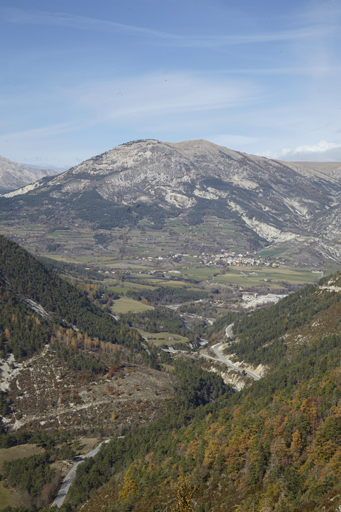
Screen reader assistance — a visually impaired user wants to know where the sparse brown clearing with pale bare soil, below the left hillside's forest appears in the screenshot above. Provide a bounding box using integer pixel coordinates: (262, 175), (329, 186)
(4, 346), (175, 437)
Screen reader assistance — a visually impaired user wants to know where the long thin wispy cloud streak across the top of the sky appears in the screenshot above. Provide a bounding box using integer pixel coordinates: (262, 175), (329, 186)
(0, 8), (336, 48)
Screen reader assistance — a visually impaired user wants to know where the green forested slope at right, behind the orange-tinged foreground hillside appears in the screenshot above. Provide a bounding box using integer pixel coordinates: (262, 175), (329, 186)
(225, 273), (341, 368)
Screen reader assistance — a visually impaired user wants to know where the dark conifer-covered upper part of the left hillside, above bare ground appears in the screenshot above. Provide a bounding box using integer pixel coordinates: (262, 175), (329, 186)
(0, 236), (156, 366)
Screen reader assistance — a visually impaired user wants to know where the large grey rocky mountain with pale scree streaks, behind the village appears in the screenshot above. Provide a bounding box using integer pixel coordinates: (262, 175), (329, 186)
(0, 140), (341, 264)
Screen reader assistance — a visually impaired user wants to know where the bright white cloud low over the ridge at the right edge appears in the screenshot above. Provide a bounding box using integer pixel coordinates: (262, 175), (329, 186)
(260, 140), (341, 162)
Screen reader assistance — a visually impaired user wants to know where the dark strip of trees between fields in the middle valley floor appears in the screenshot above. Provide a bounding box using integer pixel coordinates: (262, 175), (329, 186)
(127, 286), (209, 305)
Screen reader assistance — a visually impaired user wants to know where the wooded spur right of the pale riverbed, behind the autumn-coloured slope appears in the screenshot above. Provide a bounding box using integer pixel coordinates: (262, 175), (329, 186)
(226, 285), (341, 366)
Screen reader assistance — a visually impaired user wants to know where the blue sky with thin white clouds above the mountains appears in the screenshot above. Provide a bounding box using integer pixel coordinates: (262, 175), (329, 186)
(0, 0), (341, 168)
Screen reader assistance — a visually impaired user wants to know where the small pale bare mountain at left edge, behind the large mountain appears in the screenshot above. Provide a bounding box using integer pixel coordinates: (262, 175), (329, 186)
(0, 156), (56, 194)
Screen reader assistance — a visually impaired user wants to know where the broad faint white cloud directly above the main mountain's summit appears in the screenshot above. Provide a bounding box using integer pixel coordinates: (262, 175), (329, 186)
(71, 73), (261, 123)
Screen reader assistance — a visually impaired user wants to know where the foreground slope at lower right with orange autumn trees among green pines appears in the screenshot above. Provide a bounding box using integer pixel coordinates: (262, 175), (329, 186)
(65, 330), (341, 512)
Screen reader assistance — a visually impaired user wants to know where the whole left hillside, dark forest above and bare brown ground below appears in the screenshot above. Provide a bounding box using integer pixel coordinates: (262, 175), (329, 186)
(0, 236), (170, 433)
